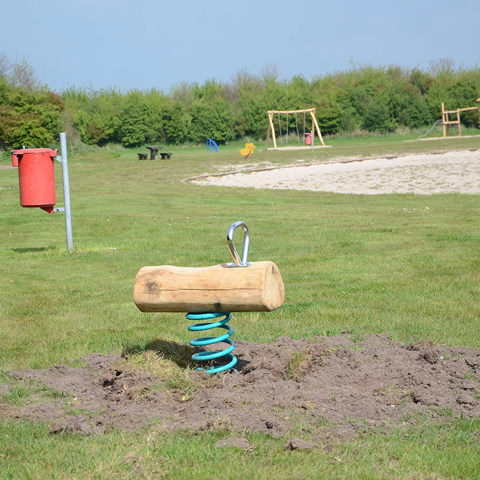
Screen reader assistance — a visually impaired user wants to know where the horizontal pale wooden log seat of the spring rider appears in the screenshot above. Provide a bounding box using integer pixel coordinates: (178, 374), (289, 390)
(133, 262), (285, 313)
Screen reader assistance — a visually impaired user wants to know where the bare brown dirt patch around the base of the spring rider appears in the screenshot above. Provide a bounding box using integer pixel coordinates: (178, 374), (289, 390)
(0, 335), (480, 437)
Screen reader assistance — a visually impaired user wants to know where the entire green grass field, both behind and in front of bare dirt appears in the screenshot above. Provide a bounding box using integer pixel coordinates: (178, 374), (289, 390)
(0, 136), (480, 479)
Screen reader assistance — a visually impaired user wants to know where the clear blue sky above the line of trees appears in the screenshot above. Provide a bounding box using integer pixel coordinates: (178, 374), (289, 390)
(0, 0), (480, 92)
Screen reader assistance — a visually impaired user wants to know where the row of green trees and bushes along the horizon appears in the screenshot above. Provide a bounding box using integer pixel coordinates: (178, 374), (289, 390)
(0, 56), (480, 149)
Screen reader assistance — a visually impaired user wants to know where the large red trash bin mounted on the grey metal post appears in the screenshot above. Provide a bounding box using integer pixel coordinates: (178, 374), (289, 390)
(11, 148), (58, 213)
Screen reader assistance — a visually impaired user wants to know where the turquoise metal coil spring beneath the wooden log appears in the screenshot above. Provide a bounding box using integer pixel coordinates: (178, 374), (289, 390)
(185, 313), (237, 373)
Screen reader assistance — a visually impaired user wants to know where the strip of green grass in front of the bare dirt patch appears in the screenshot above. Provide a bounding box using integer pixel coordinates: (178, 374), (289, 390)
(0, 420), (480, 480)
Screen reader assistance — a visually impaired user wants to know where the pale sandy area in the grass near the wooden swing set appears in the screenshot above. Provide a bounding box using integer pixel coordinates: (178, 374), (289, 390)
(191, 149), (480, 195)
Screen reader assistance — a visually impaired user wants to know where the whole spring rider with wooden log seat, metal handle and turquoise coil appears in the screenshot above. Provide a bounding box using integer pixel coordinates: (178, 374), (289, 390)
(133, 221), (285, 373)
